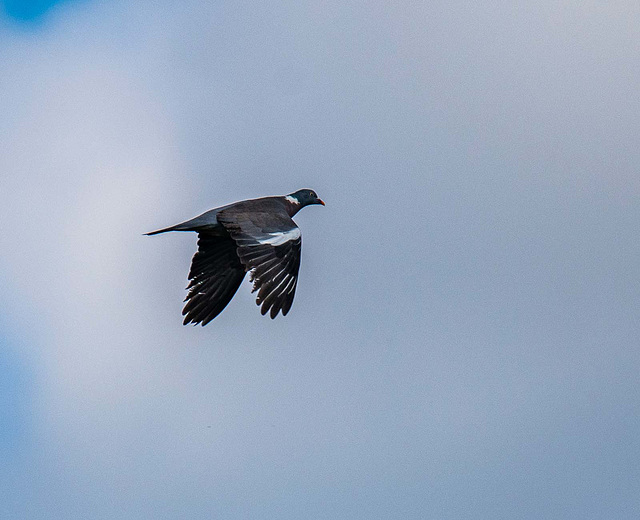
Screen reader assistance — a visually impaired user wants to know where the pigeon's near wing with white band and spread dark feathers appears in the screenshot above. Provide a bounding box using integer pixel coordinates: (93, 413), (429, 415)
(218, 208), (302, 318)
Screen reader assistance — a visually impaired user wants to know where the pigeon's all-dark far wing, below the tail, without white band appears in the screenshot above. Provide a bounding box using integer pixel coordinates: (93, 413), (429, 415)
(182, 232), (246, 326)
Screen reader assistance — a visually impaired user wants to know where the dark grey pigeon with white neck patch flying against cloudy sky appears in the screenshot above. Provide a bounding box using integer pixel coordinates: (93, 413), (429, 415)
(145, 189), (325, 326)
